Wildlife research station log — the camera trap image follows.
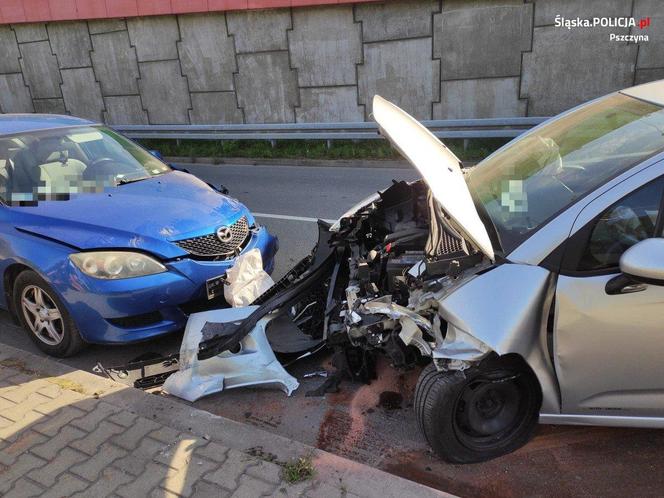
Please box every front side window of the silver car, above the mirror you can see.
[578,178,664,271]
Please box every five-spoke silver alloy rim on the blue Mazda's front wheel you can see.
[21,285,65,346]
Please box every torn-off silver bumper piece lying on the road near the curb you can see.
[164,306,299,401]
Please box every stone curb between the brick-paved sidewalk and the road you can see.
[0,345,454,498]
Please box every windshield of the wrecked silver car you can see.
[467,94,664,254]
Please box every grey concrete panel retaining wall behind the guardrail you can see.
[0,0,664,124]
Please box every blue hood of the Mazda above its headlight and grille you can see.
[8,171,253,258]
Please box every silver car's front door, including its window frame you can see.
[553,172,664,416]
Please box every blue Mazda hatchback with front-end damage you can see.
[0,114,277,357]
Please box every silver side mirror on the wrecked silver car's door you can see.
[620,238,664,285]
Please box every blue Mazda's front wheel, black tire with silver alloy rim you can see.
[12,270,85,358]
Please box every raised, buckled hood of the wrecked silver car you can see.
[373,95,495,261]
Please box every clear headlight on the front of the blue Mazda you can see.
[69,251,166,280]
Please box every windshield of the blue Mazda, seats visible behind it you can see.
[0,126,171,204]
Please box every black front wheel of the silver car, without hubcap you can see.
[415,357,542,463]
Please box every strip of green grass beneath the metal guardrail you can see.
[138,139,506,160]
